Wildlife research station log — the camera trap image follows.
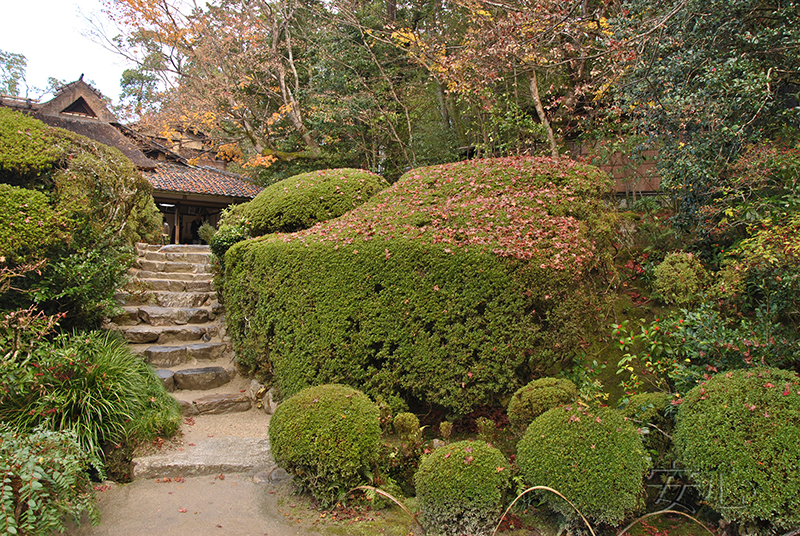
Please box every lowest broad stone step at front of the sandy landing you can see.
[131,437,276,479]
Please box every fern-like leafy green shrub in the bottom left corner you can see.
[0,423,100,536]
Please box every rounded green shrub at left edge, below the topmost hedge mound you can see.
[0,183,64,264]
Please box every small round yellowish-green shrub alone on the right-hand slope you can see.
[653,252,708,305]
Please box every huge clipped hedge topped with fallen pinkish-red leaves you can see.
[225,158,614,413]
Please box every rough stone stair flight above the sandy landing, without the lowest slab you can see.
[106,244,252,416]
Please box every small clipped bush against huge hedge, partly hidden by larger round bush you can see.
[508,378,578,434]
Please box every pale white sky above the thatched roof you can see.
[0,0,131,104]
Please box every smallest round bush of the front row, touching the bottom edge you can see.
[414,441,509,536]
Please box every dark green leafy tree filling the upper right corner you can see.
[615,0,800,234]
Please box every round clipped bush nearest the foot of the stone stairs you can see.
[269,384,381,506]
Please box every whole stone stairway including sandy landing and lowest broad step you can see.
[106,244,288,480]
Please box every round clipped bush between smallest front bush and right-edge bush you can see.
[517,406,650,525]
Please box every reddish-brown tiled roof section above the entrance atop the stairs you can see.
[145,162,262,199]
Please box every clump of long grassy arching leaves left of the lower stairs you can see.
[0,332,180,466]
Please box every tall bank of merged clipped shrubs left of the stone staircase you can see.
[0,108,161,327]
